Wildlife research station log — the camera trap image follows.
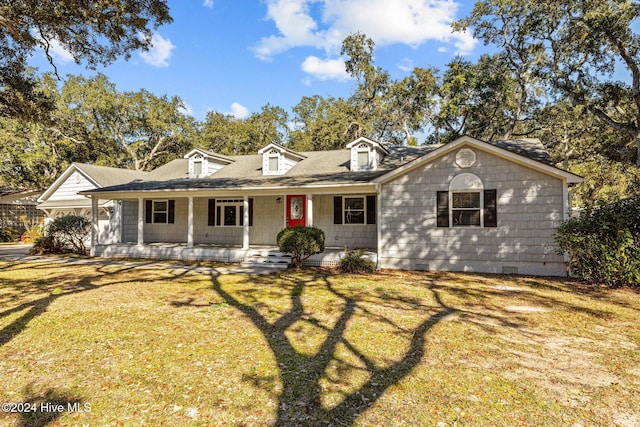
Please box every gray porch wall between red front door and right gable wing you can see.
[313,194,377,249]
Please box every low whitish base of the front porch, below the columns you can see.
[92,243,378,268]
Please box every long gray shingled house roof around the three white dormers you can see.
[76,136,582,195]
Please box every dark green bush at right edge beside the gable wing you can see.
[555,194,640,286]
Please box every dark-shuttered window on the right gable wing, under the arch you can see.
[436,190,498,227]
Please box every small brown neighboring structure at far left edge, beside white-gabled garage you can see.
[0,188,44,231]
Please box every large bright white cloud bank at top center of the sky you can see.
[255,0,477,59]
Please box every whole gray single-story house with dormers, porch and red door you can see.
[41,137,582,275]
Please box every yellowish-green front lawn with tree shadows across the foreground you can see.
[0,262,640,426]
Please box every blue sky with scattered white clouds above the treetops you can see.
[25,0,485,120]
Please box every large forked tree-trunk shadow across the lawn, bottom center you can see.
[211,275,454,426]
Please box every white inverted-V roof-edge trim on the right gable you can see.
[371,136,583,184]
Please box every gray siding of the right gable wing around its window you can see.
[379,150,565,275]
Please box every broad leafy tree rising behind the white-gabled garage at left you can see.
[61,74,196,170]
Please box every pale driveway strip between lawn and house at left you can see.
[0,243,283,276]
